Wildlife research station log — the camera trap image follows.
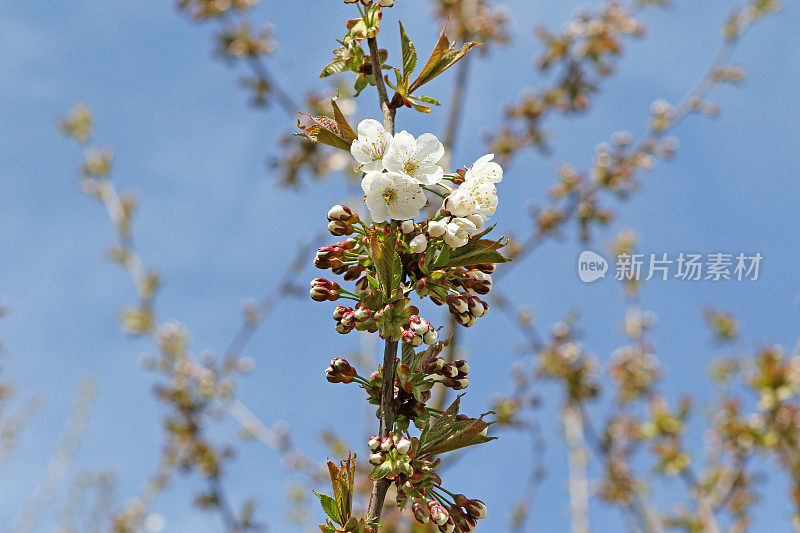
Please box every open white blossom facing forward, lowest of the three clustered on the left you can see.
[361,172,427,222]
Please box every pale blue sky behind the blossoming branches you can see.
[0,0,800,532]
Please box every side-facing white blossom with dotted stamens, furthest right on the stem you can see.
[444,154,503,218]
